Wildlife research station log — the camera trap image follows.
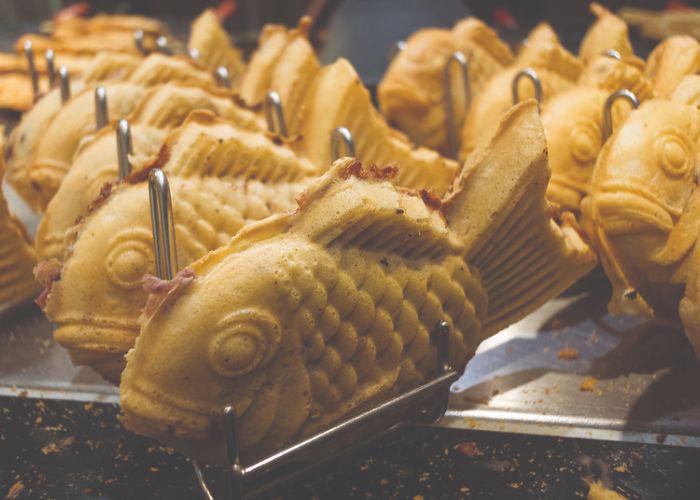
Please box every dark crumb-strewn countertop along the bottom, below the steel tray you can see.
[0,397,700,500]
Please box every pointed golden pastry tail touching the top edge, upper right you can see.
[578,2,634,64]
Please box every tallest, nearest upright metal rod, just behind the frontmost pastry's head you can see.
[148,168,178,280]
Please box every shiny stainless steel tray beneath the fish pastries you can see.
[0,287,700,447]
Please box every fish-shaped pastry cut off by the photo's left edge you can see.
[0,126,39,311]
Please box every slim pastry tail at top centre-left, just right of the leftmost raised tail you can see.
[237,17,311,107]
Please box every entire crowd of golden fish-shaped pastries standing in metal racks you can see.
[5,0,700,468]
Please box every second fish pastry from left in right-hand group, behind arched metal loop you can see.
[459,34,583,159]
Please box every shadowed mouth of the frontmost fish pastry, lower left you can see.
[120,382,213,440]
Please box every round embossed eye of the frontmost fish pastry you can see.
[208,309,282,377]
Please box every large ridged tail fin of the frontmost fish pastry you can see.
[443,99,596,335]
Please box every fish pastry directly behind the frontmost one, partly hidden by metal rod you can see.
[42,177,300,382]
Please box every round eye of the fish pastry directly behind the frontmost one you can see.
[105,228,155,289]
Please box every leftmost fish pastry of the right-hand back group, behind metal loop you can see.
[377,17,513,154]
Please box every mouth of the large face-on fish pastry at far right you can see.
[594,185,673,235]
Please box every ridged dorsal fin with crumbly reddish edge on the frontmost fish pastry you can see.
[289,158,461,259]
